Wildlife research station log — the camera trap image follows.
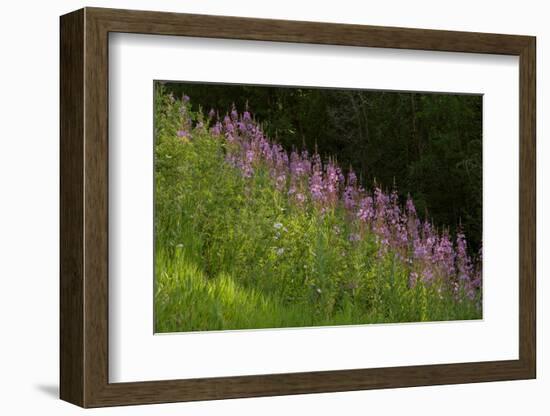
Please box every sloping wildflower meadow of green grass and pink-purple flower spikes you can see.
[154,85,482,332]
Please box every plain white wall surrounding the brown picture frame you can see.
[0,0,550,415]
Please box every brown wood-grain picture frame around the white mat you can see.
[60,8,536,407]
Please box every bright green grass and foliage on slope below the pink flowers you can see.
[155,92,480,332]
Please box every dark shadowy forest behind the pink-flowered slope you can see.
[158,83,482,251]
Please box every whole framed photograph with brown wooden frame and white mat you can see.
[60,8,536,407]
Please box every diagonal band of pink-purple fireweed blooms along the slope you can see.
[181,96,482,299]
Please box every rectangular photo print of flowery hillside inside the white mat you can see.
[154,80,483,333]
